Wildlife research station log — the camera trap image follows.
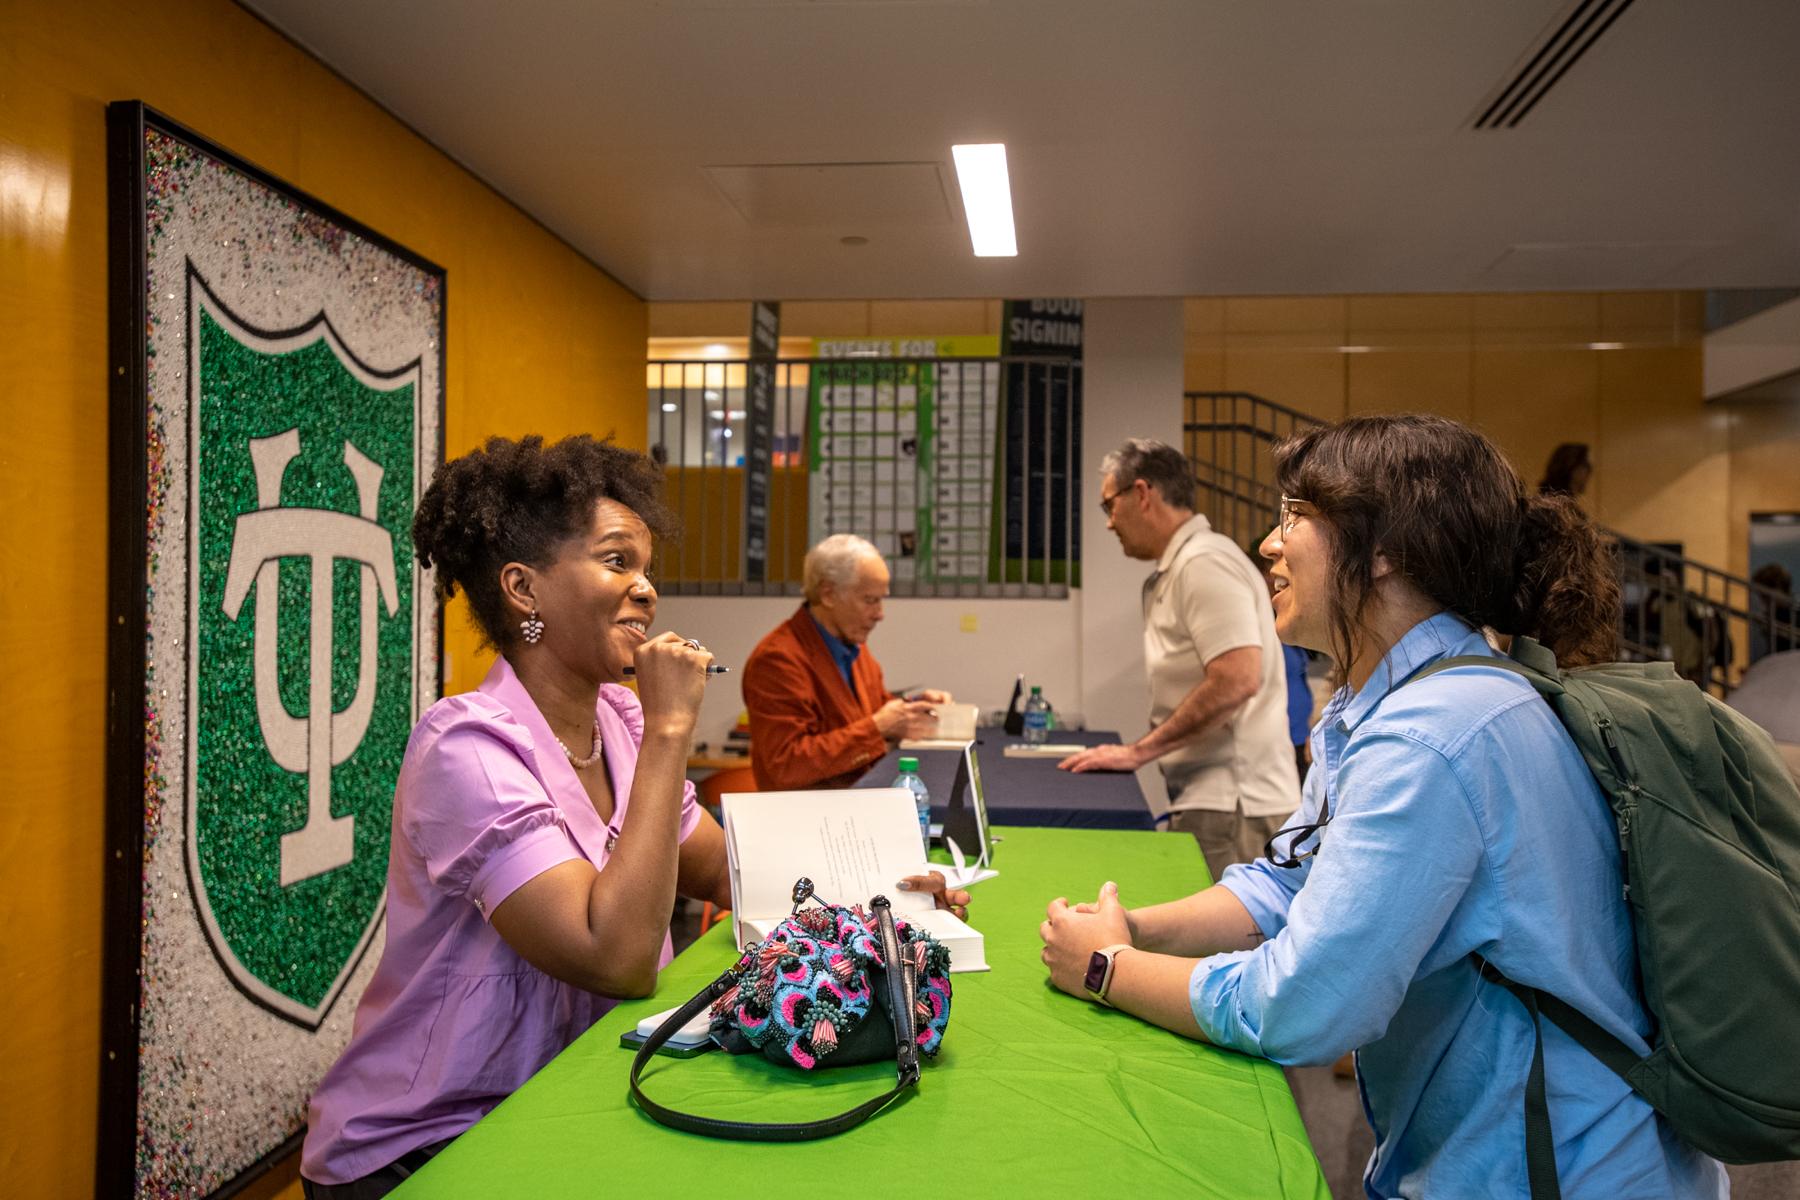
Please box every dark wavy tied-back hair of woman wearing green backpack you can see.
[1274,414,1620,667]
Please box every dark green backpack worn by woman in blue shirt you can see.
[1413,637,1800,1200]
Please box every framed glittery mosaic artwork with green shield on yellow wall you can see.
[97,103,445,1196]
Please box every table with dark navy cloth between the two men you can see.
[855,729,1154,829]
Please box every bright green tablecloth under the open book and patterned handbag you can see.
[398,828,1330,1200]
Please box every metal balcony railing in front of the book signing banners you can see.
[646,356,1082,597]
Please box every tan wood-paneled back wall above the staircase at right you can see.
[1184,291,1800,574]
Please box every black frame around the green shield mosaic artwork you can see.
[94,101,448,1200]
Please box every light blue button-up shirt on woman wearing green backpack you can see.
[1188,613,1728,1200]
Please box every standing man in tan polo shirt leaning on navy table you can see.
[1058,437,1300,882]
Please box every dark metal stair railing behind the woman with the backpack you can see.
[1183,392,1800,696]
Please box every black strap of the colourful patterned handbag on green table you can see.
[632,896,918,1142]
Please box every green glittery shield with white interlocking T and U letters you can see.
[187,266,417,1029]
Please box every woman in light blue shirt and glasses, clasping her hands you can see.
[1042,416,1728,1200]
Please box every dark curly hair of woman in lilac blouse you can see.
[412,434,675,649]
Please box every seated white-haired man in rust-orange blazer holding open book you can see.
[743,533,950,792]
